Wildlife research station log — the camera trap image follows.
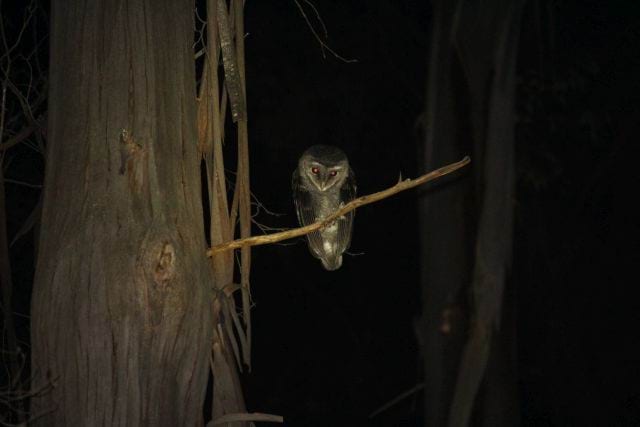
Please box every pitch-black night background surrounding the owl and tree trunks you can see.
[3,0,640,426]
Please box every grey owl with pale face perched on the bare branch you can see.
[291,145,356,271]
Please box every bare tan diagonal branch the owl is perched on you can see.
[207,156,471,256]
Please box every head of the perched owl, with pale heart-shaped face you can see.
[298,145,349,192]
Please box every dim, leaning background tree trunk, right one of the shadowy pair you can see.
[449,0,522,427]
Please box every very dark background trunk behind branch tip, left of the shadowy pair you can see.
[419,1,470,426]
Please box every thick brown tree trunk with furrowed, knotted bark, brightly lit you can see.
[32,0,212,426]
